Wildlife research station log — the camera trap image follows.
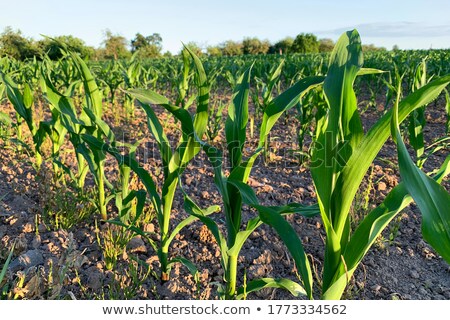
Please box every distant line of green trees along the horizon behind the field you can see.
[0,27,385,60]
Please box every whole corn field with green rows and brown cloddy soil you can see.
[0,30,450,299]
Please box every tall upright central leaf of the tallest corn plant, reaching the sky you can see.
[311,30,364,290]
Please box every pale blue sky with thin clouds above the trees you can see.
[0,0,450,53]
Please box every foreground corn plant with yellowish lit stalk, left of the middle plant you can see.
[89,46,218,281]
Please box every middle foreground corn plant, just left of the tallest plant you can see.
[173,62,323,299]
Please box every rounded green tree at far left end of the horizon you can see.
[0,27,40,60]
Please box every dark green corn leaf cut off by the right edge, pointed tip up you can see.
[392,92,450,263]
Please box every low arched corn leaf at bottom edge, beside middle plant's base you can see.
[236,278,307,300]
